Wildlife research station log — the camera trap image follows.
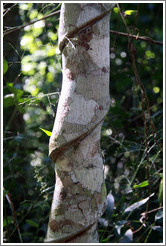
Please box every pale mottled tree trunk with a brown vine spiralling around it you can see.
[45,3,113,243]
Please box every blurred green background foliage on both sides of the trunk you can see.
[3,2,163,243]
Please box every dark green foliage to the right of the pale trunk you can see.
[100,4,163,243]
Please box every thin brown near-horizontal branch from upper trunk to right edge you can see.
[110,30,163,45]
